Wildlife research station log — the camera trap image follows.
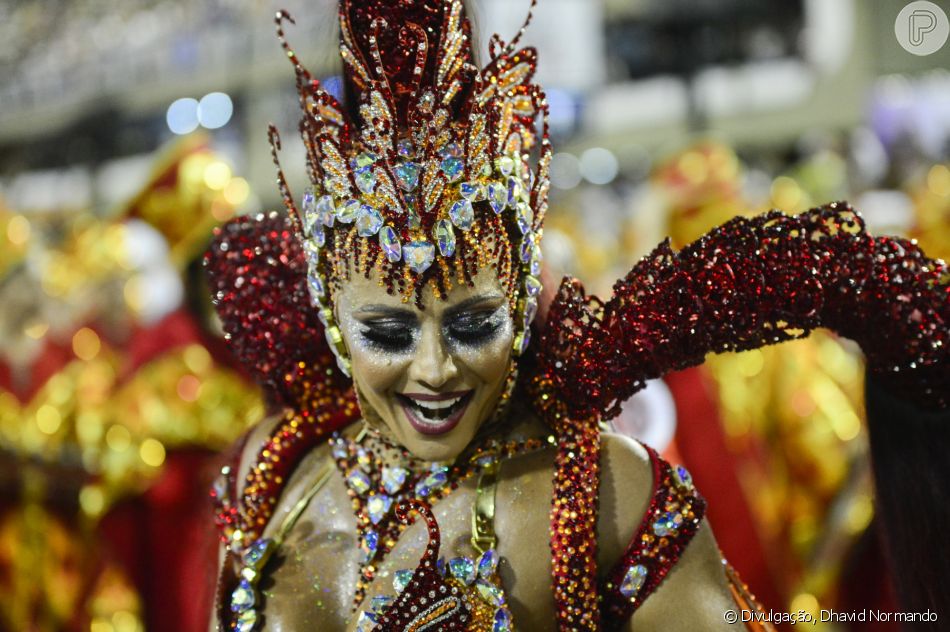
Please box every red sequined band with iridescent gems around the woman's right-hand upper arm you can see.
[602,446,706,629]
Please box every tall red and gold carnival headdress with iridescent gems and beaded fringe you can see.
[270,0,551,373]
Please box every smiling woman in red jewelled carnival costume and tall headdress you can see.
[207,0,950,631]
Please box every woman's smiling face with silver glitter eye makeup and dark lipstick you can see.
[335,267,514,461]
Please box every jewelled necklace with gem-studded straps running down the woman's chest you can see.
[229,426,553,632]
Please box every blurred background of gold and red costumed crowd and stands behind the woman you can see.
[0,0,950,632]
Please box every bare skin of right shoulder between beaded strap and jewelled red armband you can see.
[597,433,653,576]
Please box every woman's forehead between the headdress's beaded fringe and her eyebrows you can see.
[336,266,505,313]
